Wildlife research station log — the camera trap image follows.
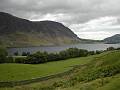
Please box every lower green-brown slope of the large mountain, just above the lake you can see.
[0,32,78,47]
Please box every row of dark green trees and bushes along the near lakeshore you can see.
[0,47,120,64]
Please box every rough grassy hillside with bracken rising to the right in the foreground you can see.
[1,51,120,90]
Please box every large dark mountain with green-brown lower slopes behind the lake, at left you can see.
[0,12,80,47]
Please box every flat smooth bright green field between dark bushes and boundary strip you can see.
[0,52,97,81]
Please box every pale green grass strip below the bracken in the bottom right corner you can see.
[59,74,120,90]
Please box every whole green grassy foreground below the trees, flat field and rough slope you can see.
[0,51,120,90]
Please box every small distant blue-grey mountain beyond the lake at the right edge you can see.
[104,34,120,44]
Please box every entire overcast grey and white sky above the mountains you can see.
[0,0,120,40]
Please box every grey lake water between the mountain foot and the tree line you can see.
[7,44,120,55]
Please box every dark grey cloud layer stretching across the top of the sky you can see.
[0,0,120,22]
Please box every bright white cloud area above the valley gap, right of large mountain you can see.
[70,16,120,40]
